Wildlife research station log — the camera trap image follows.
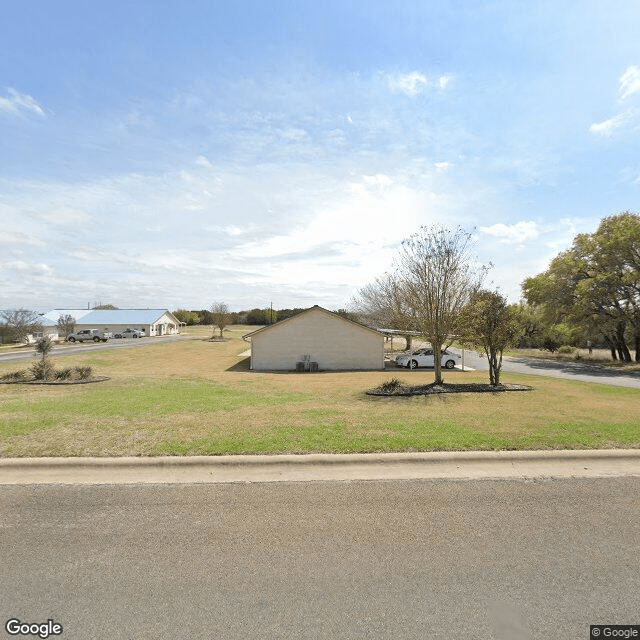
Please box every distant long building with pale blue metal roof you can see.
[35,309,180,338]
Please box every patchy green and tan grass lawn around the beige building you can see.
[0,327,640,457]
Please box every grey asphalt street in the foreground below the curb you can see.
[0,478,640,640]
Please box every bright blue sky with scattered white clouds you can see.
[0,0,640,310]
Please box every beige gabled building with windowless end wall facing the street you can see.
[243,305,384,371]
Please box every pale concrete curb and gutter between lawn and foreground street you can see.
[0,449,640,485]
